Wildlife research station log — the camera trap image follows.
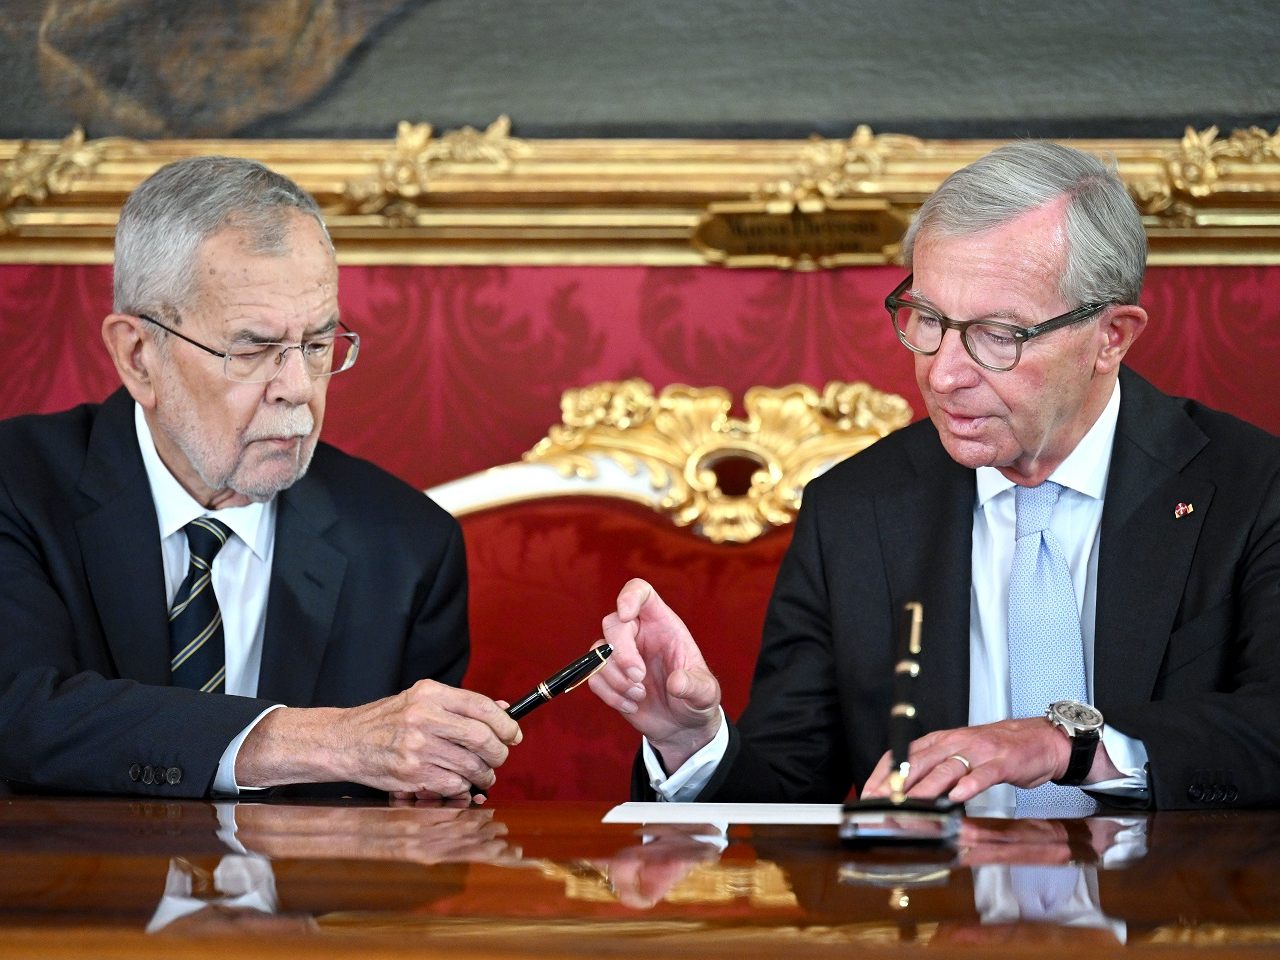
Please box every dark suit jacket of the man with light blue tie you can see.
[700,370,1280,808]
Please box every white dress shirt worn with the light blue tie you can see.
[641,381,1147,815]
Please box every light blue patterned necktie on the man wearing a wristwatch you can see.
[1009,480,1097,817]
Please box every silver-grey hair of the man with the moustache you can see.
[113,156,333,323]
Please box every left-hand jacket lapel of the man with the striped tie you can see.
[76,389,170,685]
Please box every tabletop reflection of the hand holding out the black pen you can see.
[236,804,520,864]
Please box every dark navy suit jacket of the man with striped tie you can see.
[0,390,467,796]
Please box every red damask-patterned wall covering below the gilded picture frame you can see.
[0,265,1280,486]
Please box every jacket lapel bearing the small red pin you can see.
[1093,370,1215,713]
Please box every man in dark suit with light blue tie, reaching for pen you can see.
[591,142,1280,812]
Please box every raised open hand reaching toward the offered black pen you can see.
[589,580,721,772]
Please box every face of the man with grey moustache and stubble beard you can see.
[148,214,338,507]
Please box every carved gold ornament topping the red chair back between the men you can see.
[525,379,911,543]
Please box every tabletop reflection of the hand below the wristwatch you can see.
[956,817,1124,867]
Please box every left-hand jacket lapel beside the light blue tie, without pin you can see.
[879,429,977,731]
